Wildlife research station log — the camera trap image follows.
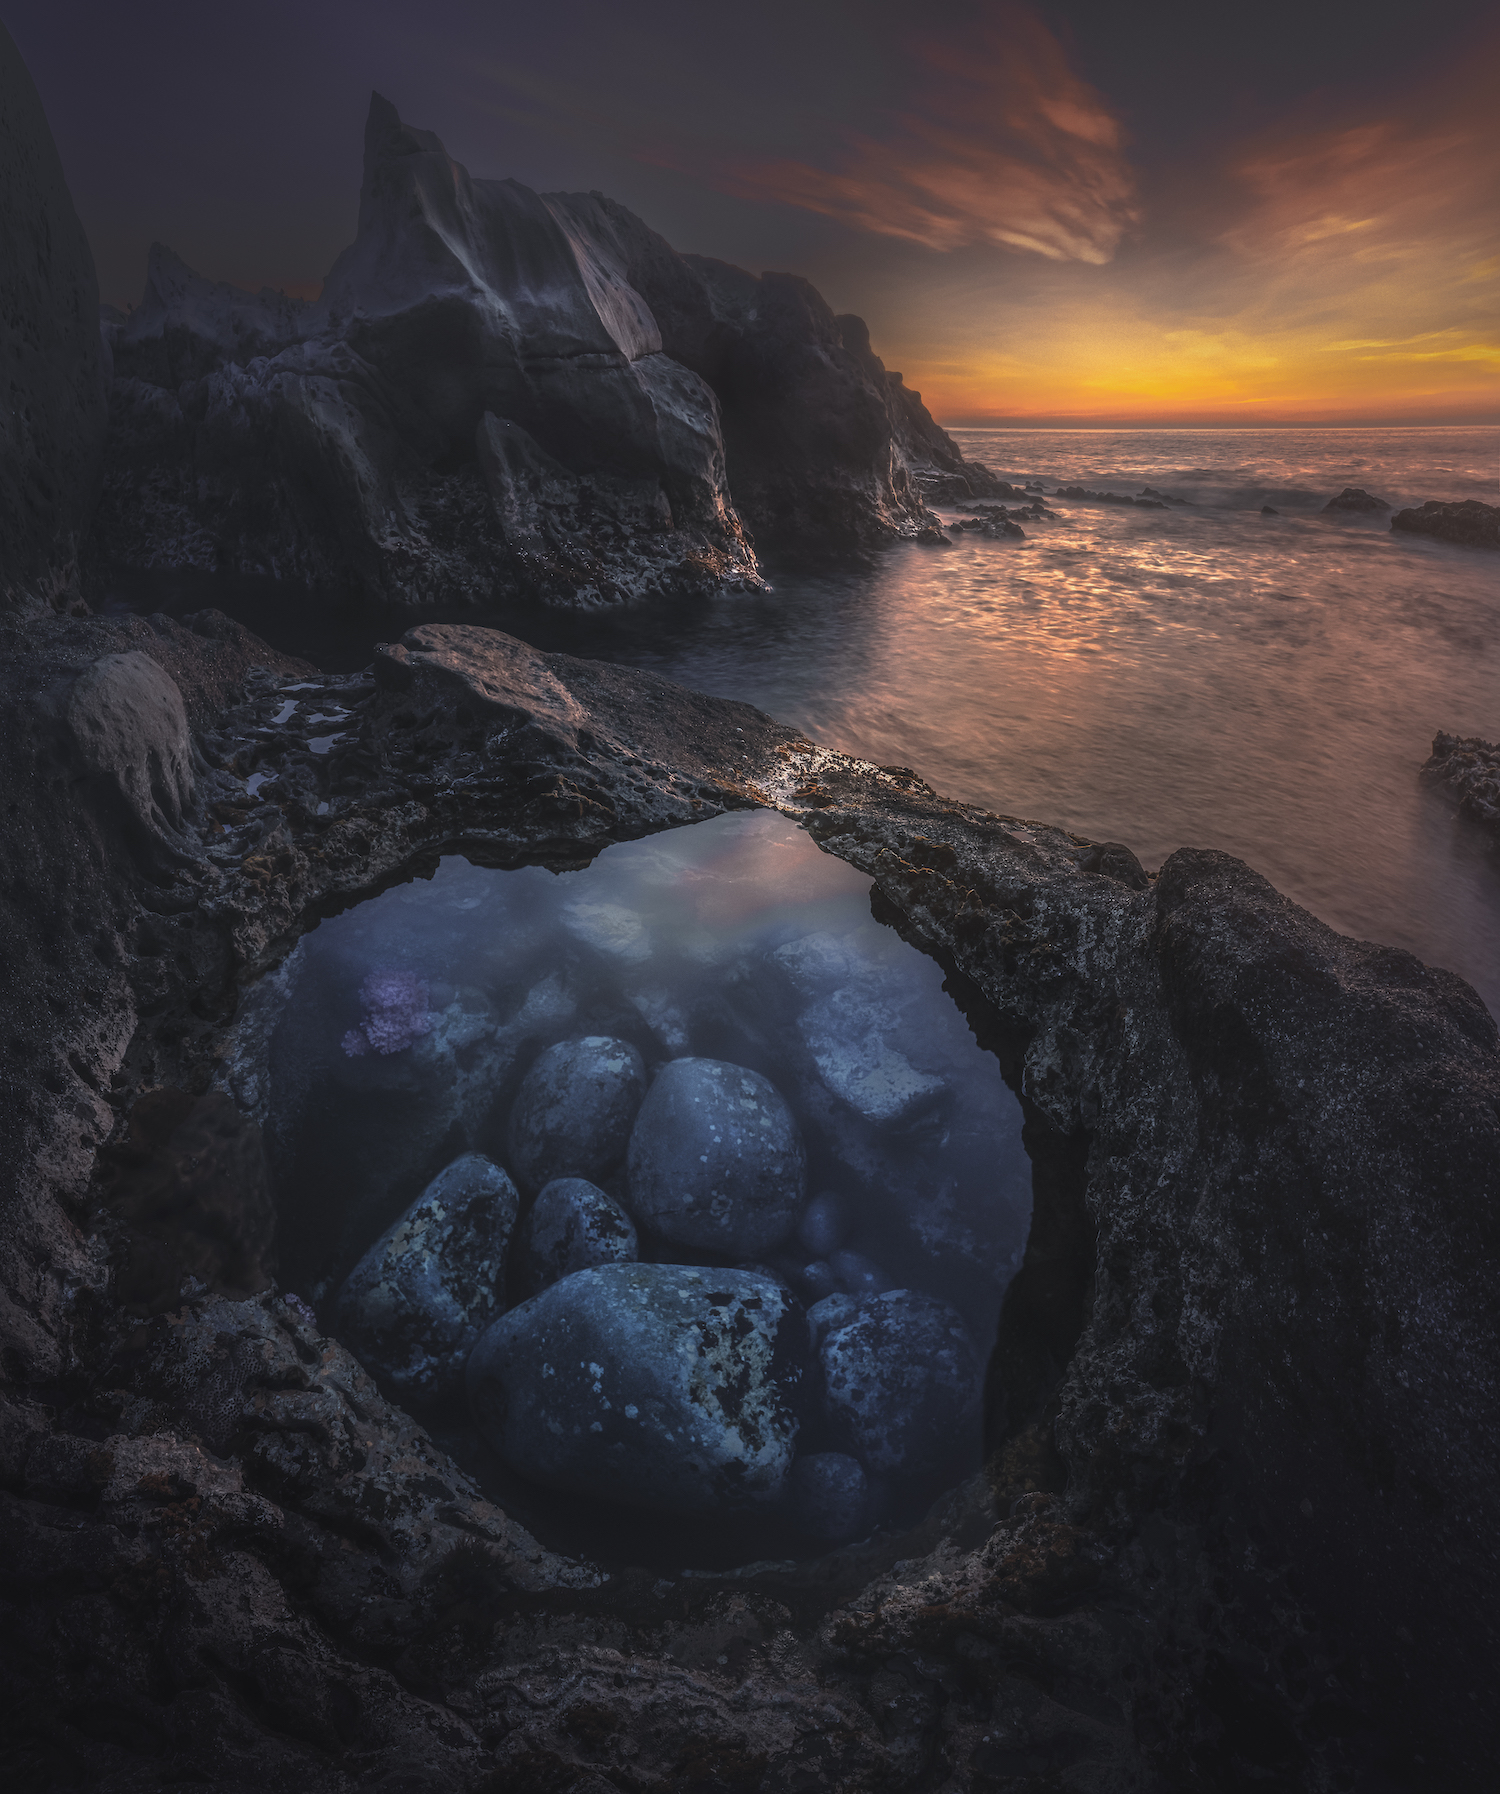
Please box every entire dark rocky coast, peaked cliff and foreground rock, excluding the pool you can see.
[0,21,1500,1794]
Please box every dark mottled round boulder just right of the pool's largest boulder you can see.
[818,1290,980,1475]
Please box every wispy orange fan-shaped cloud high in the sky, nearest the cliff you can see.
[653,5,1138,264]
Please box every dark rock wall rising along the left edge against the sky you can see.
[0,25,108,612]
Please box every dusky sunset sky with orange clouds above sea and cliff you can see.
[11,0,1500,427]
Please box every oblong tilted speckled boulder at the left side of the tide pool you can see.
[337,1154,520,1401]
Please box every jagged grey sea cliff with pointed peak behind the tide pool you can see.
[99,95,985,608]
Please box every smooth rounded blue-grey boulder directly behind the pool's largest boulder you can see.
[628,1058,807,1258]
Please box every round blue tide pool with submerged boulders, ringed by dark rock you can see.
[267,813,1032,1564]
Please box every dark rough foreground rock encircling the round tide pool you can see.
[0,619,1500,1794]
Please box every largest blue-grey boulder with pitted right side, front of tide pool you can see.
[468,1265,806,1514]
